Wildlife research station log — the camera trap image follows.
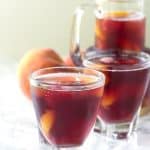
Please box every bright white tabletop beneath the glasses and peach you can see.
[0,66,150,150]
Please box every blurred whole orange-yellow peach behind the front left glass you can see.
[17,48,64,99]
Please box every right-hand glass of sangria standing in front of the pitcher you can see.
[83,51,150,139]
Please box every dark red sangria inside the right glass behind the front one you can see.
[87,55,150,123]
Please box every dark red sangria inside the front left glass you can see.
[32,74,103,147]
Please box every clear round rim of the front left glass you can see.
[29,66,105,91]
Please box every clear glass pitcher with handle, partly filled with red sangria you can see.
[70,0,146,65]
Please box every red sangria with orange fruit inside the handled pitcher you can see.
[95,12,145,51]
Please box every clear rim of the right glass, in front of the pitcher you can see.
[83,51,150,72]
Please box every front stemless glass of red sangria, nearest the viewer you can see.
[30,67,105,149]
